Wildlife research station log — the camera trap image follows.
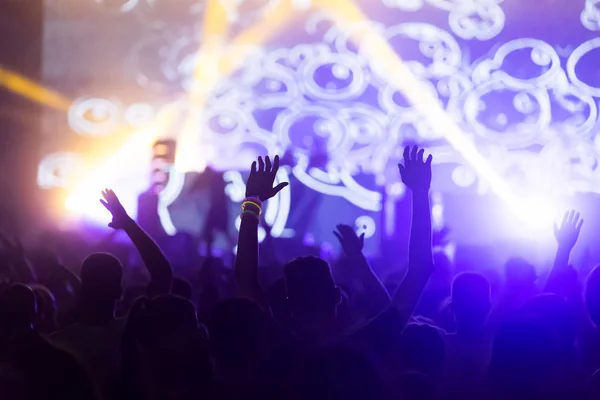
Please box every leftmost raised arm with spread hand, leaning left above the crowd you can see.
[100,190,173,295]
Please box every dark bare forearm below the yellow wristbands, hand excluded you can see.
[234,217,267,307]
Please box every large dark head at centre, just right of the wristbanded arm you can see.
[284,256,341,318]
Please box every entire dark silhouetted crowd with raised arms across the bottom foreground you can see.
[0,147,600,400]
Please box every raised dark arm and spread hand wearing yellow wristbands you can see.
[234,156,288,309]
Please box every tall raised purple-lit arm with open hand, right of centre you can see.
[392,146,433,332]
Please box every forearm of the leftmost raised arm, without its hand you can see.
[125,219,173,294]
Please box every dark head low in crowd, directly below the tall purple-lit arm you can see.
[400,323,446,378]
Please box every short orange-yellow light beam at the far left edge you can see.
[0,67,71,110]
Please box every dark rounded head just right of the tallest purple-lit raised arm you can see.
[451,272,492,335]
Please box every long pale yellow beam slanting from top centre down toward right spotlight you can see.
[317,0,520,212]
